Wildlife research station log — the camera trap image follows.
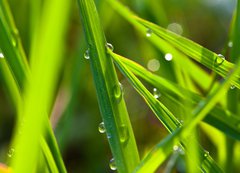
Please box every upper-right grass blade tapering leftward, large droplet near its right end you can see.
[135,17,240,88]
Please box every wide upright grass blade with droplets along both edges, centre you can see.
[78,0,139,173]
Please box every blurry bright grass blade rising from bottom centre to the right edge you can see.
[129,51,240,172]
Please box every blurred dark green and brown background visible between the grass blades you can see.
[0,0,240,173]
